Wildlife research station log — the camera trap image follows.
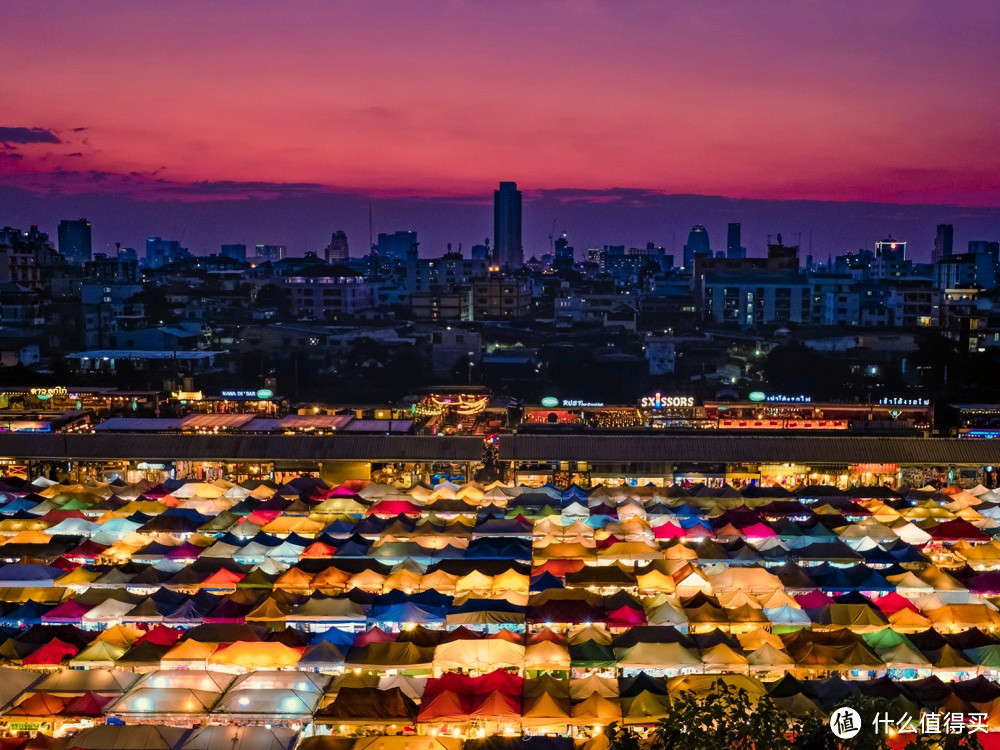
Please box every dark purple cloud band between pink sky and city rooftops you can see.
[0,183,1000,264]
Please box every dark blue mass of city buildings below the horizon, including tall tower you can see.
[0,182,1000,418]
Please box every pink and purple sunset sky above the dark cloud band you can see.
[0,0,1000,206]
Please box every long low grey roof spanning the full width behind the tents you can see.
[0,433,1000,465]
